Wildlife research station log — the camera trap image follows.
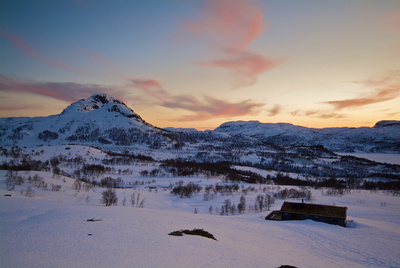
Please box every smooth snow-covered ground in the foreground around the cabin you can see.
[0,166,400,267]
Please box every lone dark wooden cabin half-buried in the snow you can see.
[265,202,347,227]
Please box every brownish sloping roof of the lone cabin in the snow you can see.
[281,202,347,219]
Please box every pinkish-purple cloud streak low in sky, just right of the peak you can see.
[130,76,264,121]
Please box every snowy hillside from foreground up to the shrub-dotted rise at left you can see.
[0,145,400,267]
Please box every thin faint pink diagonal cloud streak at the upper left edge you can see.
[0,29,86,73]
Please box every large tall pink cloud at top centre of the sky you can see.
[181,0,283,88]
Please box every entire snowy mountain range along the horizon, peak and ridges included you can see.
[0,94,400,153]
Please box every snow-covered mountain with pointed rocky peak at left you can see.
[0,94,165,147]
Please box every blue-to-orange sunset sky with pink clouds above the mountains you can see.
[0,0,400,130]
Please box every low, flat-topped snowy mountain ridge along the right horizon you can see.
[214,121,400,152]
